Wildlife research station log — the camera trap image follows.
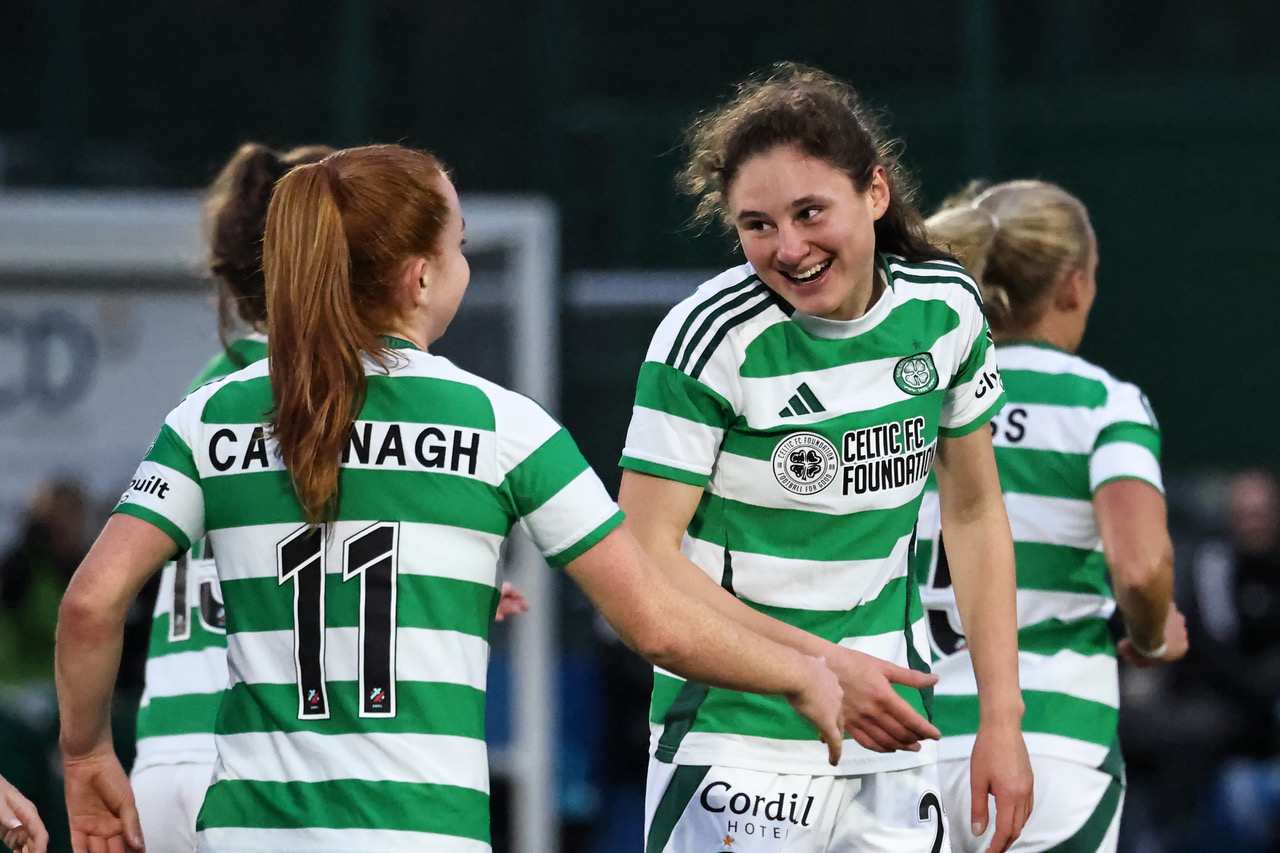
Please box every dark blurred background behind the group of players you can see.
[0,0,1280,853]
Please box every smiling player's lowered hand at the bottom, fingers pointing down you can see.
[969,722,1034,853]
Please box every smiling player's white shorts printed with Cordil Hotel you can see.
[645,757,950,853]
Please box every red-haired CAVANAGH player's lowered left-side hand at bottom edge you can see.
[63,744,143,853]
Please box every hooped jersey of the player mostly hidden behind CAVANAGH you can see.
[133,334,266,771]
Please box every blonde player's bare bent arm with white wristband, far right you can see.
[1093,479,1187,667]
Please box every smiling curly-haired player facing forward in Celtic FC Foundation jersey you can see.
[620,65,1032,853]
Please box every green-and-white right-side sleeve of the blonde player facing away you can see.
[1089,383,1165,492]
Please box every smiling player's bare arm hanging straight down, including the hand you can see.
[937,428,1033,853]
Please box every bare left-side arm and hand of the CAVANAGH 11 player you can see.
[55,515,174,853]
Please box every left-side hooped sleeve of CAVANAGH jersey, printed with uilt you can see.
[113,397,205,551]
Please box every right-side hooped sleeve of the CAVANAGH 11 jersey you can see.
[494,393,622,566]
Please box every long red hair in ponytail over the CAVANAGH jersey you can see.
[262,145,449,524]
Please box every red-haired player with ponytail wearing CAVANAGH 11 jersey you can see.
[58,146,842,853]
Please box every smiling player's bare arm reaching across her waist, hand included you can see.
[618,470,941,752]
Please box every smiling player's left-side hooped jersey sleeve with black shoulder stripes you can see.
[620,298,737,488]
